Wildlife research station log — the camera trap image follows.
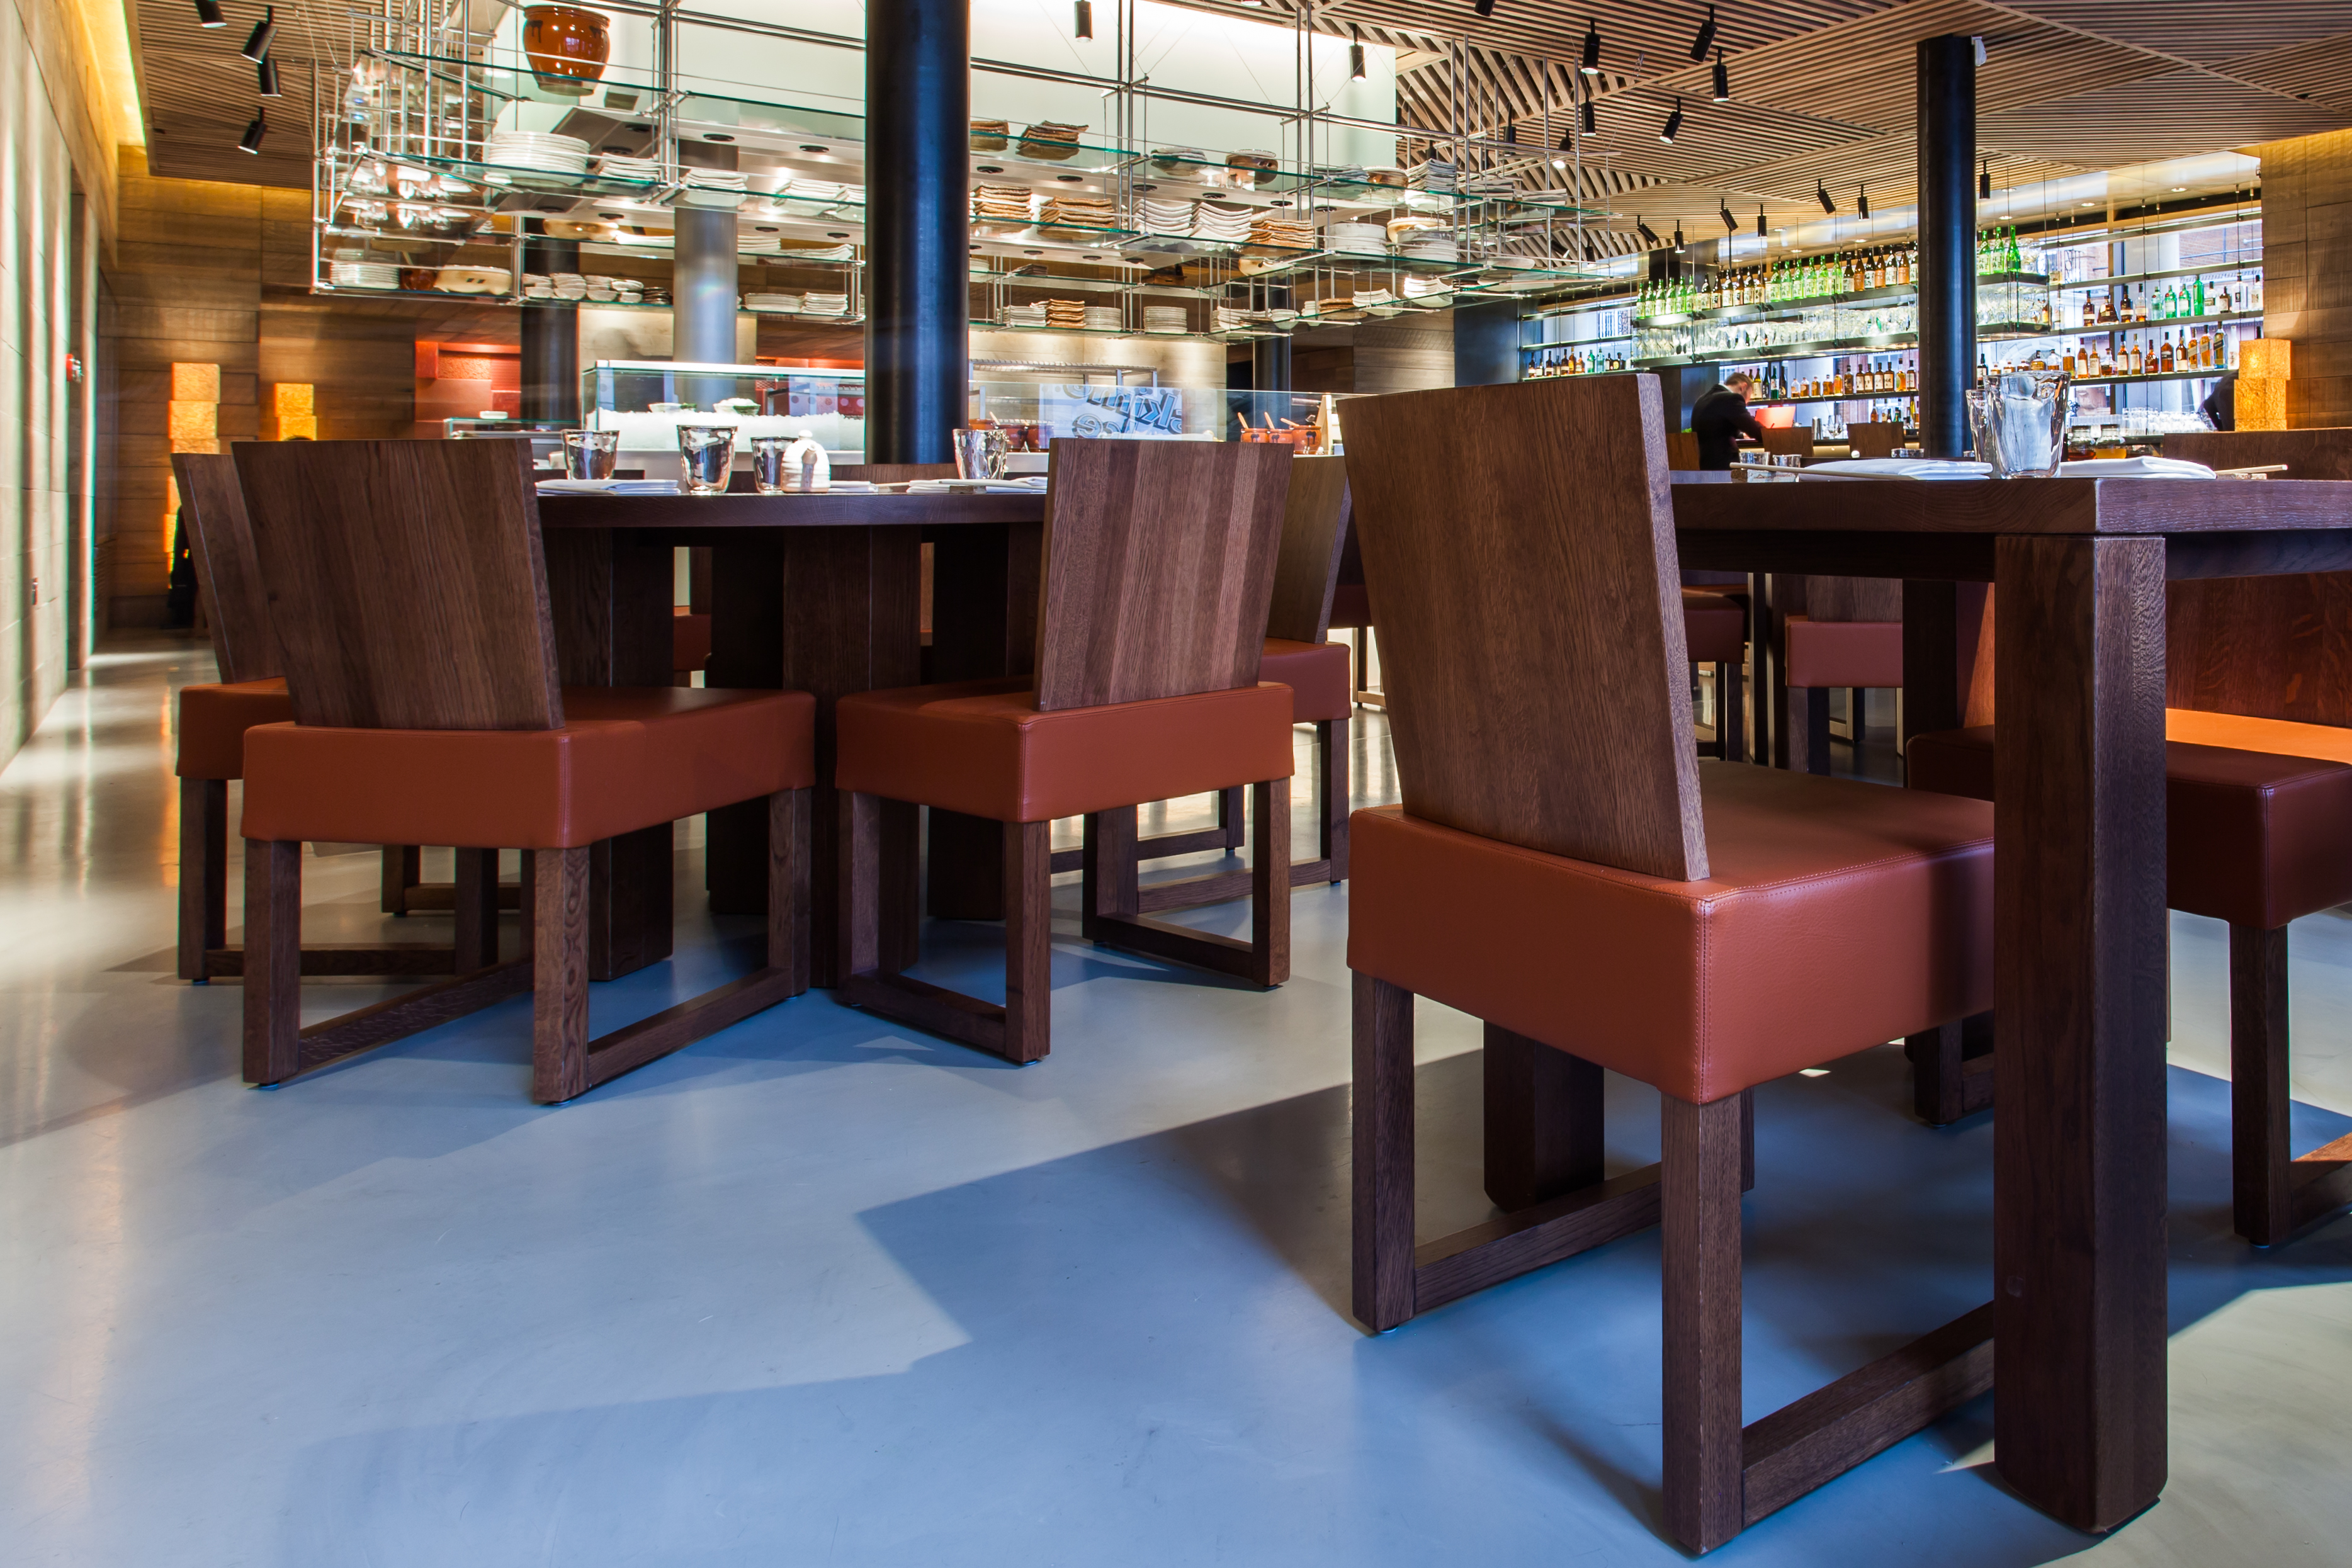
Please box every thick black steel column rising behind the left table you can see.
[866,0,971,463]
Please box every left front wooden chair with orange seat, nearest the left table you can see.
[235,442,816,1103]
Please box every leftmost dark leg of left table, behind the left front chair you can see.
[543,529,675,980]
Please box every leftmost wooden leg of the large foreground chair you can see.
[1352,973,1413,1333]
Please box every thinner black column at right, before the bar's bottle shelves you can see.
[1919,33,1976,458]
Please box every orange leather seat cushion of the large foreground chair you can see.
[1348,762,1992,1105]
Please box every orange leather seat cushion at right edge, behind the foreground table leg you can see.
[1908,708,2352,931]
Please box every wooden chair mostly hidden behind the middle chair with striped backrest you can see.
[1054,458,1355,915]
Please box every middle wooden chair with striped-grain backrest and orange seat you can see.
[835,439,1294,1063]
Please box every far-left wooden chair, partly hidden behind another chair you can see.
[172,451,456,985]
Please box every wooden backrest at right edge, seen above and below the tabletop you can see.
[2164,430,2352,726]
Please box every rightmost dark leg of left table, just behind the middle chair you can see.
[924,522,1044,919]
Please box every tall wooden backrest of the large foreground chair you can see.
[1348,376,1707,881]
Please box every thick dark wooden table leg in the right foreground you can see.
[1994,536,2166,1530]
